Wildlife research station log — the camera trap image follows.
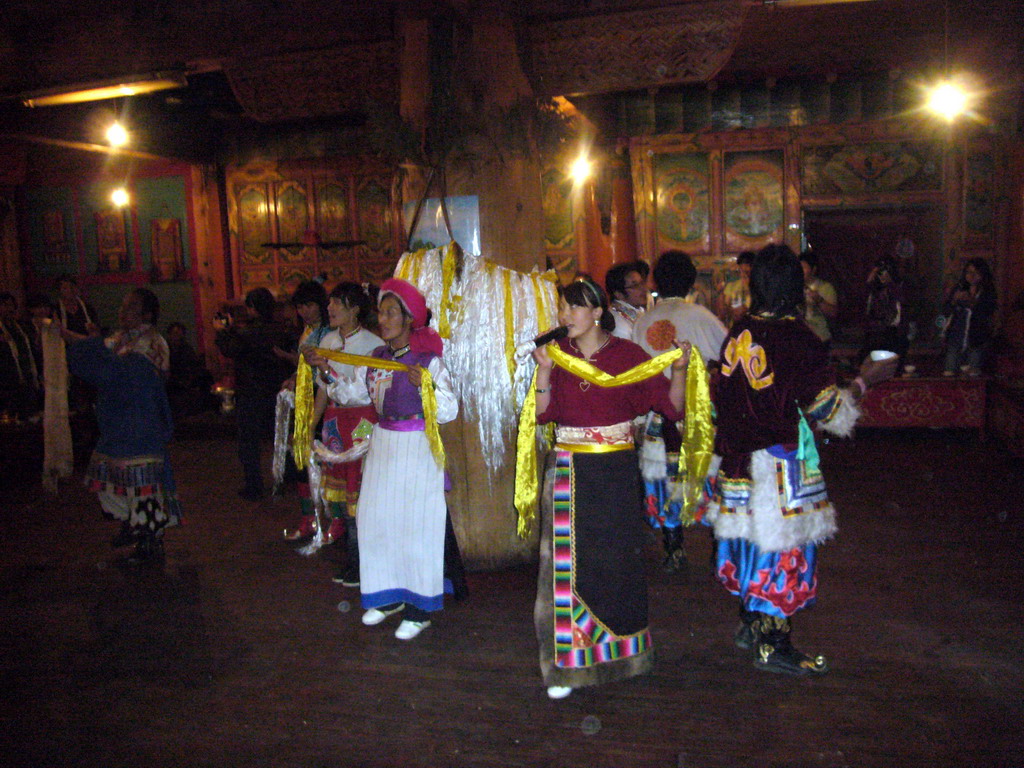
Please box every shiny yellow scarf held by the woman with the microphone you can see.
[514,344,714,538]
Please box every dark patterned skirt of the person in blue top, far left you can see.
[85,453,181,534]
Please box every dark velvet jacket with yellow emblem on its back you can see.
[715,315,835,476]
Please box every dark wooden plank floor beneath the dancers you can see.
[0,421,1024,768]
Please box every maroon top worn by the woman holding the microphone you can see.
[537,336,683,427]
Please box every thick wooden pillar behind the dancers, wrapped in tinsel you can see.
[400,10,544,569]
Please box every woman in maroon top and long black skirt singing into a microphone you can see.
[520,279,689,698]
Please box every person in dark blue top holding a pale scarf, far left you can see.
[66,288,181,562]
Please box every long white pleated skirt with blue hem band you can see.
[356,425,445,611]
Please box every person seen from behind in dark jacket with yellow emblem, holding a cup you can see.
[706,246,896,675]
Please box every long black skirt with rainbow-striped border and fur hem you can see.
[535,449,653,687]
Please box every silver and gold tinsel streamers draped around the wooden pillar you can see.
[395,248,558,481]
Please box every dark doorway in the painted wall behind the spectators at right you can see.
[804,206,943,345]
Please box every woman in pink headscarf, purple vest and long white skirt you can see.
[310,279,459,640]
